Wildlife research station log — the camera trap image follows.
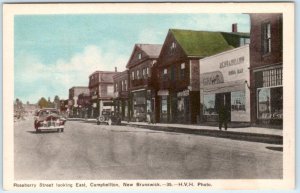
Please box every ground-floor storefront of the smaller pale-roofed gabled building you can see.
[131,89,153,122]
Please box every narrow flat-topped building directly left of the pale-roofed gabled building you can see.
[113,70,130,121]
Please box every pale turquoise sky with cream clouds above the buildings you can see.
[14,14,250,103]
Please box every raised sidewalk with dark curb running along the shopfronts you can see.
[122,121,283,144]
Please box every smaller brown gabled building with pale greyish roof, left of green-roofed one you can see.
[126,44,161,121]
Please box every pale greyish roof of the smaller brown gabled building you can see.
[126,44,162,68]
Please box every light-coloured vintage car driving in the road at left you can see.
[34,108,66,132]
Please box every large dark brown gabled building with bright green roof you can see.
[156,29,249,123]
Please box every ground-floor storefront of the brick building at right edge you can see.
[254,65,283,125]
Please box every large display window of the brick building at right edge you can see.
[257,87,283,119]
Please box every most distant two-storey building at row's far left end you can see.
[68,86,89,117]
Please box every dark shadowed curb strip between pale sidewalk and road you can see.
[128,124,283,145]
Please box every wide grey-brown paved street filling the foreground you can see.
[14,119,283,180]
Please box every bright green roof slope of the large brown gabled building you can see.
[169,29,249,57]
